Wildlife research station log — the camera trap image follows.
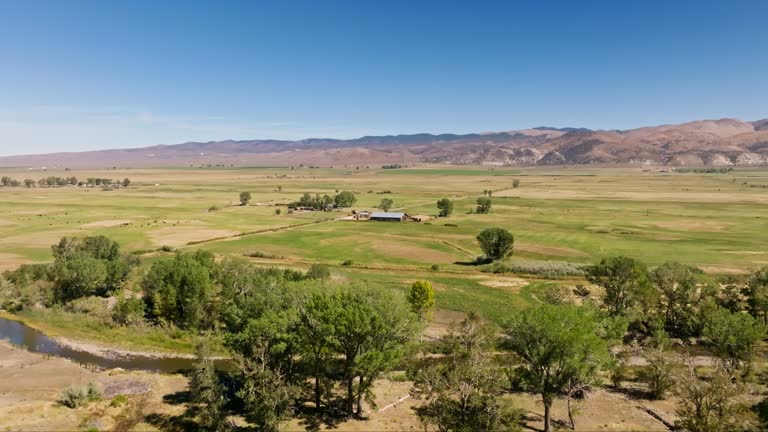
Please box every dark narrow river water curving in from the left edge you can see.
[0,317,228,373]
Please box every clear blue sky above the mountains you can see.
[0,0,768,155]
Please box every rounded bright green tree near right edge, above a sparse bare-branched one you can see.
[702,308,765,373]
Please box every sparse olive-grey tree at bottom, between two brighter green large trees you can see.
[411,315,519,432]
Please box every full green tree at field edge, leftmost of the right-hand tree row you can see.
[584,256,652,316]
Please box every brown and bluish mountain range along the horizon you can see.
[0,119,768,168]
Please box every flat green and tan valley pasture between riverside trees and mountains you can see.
[0,166,768,322]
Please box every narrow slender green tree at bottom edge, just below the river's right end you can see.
[189,342,231,432]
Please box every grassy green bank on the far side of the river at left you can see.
[0,310,228,360]
